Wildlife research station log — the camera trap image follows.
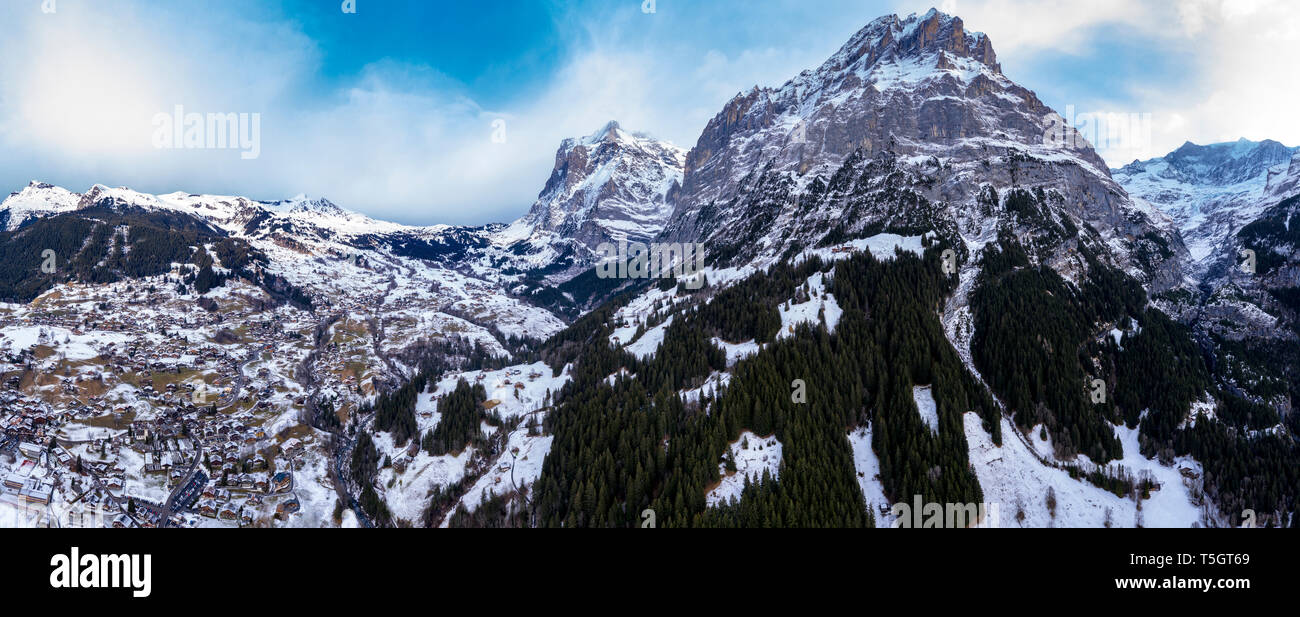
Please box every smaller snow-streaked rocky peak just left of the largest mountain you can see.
[494,121,686,281]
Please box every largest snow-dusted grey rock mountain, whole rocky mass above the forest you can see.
[667,10,1183,288]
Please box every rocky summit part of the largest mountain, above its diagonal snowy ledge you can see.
[670,10,1076,214]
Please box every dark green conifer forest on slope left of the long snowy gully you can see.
[534,248,1000,526]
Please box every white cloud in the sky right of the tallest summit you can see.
[904,0,1300,159]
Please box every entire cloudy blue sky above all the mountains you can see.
[0,0,1300,223]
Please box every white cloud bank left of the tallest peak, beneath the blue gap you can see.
[0,0,847,223]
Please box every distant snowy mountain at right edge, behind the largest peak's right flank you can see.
[1113,139,1300,340]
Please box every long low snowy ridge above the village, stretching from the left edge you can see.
[0,182,563,349]
